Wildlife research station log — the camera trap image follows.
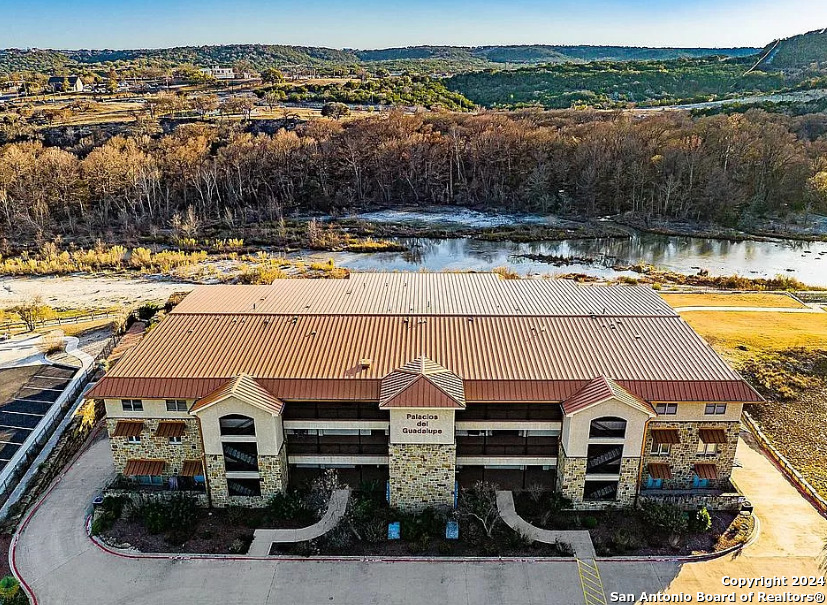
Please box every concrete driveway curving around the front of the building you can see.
[12,438,825,605]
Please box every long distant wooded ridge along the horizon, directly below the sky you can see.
[0,44,759,73]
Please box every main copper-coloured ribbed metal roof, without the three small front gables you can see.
[91,274,761,402]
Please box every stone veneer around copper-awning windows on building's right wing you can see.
[643,422,741,489]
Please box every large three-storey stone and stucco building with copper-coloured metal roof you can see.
[91,273,760,509]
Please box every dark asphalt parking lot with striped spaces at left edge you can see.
[0,365,77,470]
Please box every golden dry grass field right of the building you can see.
[664,293,827,497]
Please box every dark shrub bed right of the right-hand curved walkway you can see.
[514,491,752,556]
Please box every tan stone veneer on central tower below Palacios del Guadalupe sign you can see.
[388,443,457,510]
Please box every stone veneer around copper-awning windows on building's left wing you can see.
[106,418,204,479]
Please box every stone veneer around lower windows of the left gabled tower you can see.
[206,445,287,508]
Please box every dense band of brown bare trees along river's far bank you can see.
[0,111,827,242]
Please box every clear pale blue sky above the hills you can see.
[0,0,827,49]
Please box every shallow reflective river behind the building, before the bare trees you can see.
[304,212,827,287]
